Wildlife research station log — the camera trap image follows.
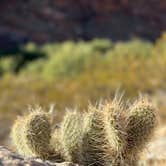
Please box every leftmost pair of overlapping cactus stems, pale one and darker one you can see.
[11,107,56,159]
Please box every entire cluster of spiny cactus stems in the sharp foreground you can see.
[11,97,156,166]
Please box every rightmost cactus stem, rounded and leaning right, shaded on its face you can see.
[125,98,156,165]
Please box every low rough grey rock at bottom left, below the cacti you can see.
[0,146,78,166]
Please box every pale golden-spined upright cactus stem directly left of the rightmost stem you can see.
[103,98,126,165]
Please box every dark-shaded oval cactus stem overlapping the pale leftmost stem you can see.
[24,109,51,159]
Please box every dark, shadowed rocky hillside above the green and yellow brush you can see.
[0,0,166,46]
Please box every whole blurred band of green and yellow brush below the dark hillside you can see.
[0,34,166,147]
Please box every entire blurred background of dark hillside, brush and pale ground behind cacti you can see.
[0,0,166,165]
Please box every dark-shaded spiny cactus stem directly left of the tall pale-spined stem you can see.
[81,107,107,166]
